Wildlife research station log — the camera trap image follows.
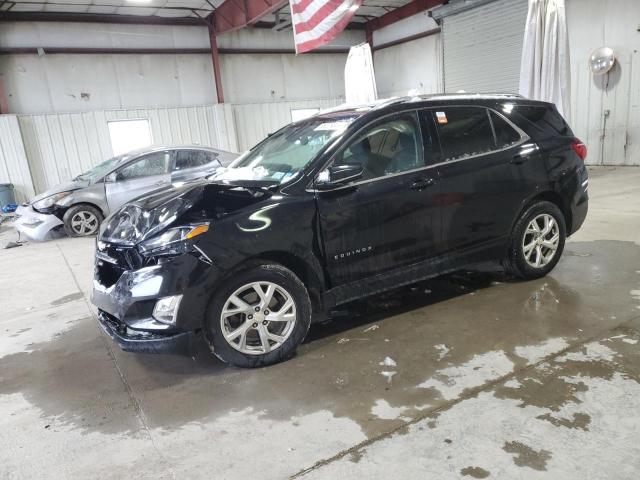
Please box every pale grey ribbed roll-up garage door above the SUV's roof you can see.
[442,0,527,93]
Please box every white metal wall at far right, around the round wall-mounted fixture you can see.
[567,0,640,165]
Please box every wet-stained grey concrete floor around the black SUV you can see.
[0,168,640,479]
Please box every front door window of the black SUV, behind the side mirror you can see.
[333,112,425,180]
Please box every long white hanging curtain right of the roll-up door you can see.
[520,0,571,122]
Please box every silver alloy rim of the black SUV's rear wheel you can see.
[522,213,560,268]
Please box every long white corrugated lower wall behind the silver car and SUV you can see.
[0,98,342,201]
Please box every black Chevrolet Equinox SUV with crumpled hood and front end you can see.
[93,95,588,367]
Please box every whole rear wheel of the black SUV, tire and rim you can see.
[508,201,567,280]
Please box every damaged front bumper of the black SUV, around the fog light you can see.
[91,247,217,353]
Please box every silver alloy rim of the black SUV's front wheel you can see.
[220,281,297,355]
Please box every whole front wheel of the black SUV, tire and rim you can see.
[207,264,312,368]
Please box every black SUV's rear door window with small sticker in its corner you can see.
[433,107,495,162]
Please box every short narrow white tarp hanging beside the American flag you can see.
[344,43,378,105]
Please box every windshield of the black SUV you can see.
[209,116,356,184]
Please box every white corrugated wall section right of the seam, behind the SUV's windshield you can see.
[234,98,344,151]
